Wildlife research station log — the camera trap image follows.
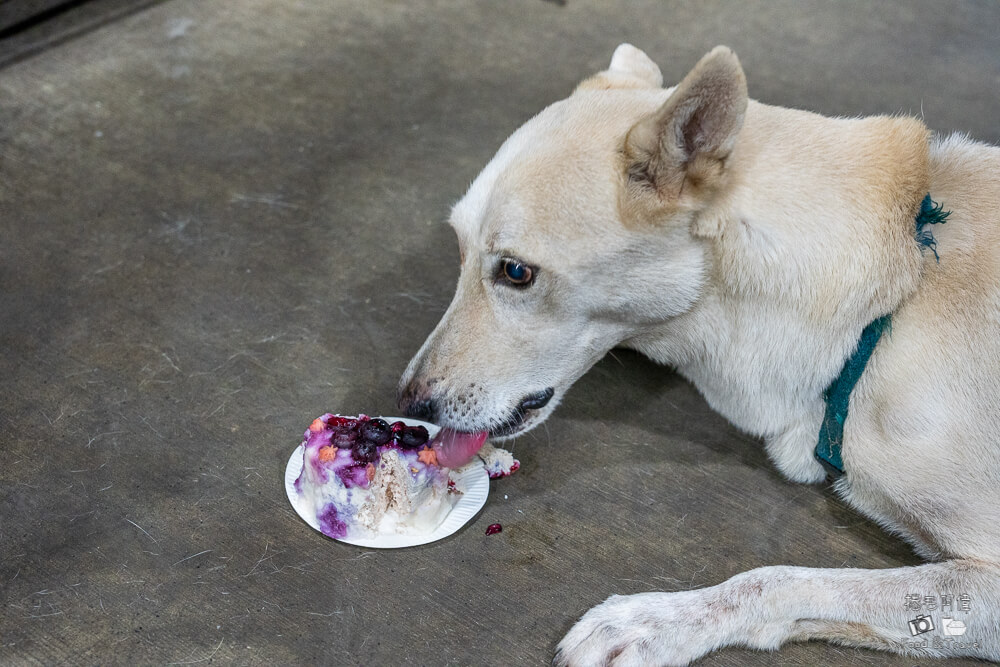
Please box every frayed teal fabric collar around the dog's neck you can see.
[816,195,951,477]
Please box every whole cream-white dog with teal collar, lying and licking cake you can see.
[400,44,1000,665]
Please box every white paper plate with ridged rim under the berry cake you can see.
[285,417,490,549]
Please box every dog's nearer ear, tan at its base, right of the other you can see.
[624,46,747,200]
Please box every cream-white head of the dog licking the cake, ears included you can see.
[399,44,747,436]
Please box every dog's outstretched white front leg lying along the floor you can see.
[553,560,1000,665]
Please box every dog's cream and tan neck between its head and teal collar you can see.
[629,103,929,437]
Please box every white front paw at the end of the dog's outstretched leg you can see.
[552,589,722,667]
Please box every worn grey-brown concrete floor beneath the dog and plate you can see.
[0,0,1000,667]
